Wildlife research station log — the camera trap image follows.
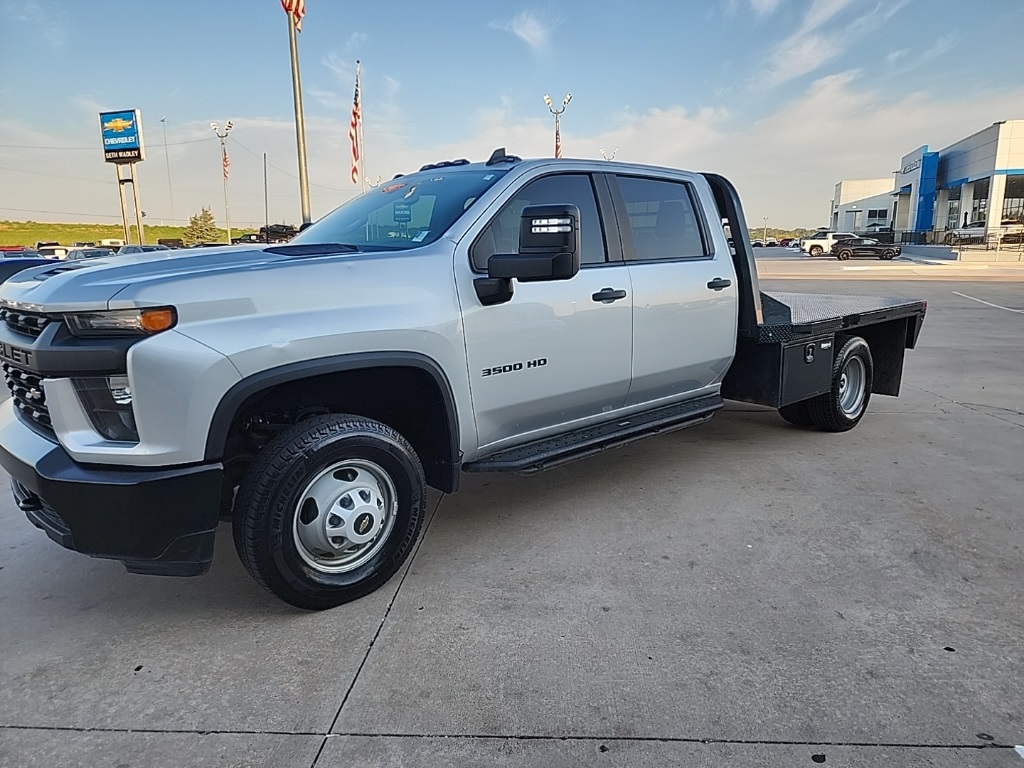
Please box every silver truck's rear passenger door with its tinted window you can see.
[610,174,738,406]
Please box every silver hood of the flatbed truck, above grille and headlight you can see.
[0,244,300,312]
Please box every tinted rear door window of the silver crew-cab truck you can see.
[616,176,709,261]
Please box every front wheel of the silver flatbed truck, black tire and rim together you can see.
[232,415,426,610]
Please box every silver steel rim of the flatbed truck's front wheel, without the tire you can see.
[292,459,398,573]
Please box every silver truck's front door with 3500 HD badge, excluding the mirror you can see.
[459,173,633,449]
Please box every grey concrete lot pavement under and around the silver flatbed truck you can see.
[0,280,1024,768]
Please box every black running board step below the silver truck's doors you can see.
[462,394,725,475]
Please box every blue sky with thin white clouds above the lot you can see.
[0,0,1024,227]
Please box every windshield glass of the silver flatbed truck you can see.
[291,168,508,251]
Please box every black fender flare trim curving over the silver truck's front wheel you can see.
[205,352,462,482]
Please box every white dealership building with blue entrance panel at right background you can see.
[830,120,1024,243]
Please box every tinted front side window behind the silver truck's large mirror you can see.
[471,173,607,272]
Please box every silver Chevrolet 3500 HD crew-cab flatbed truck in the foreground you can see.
[0,150,926,608]
